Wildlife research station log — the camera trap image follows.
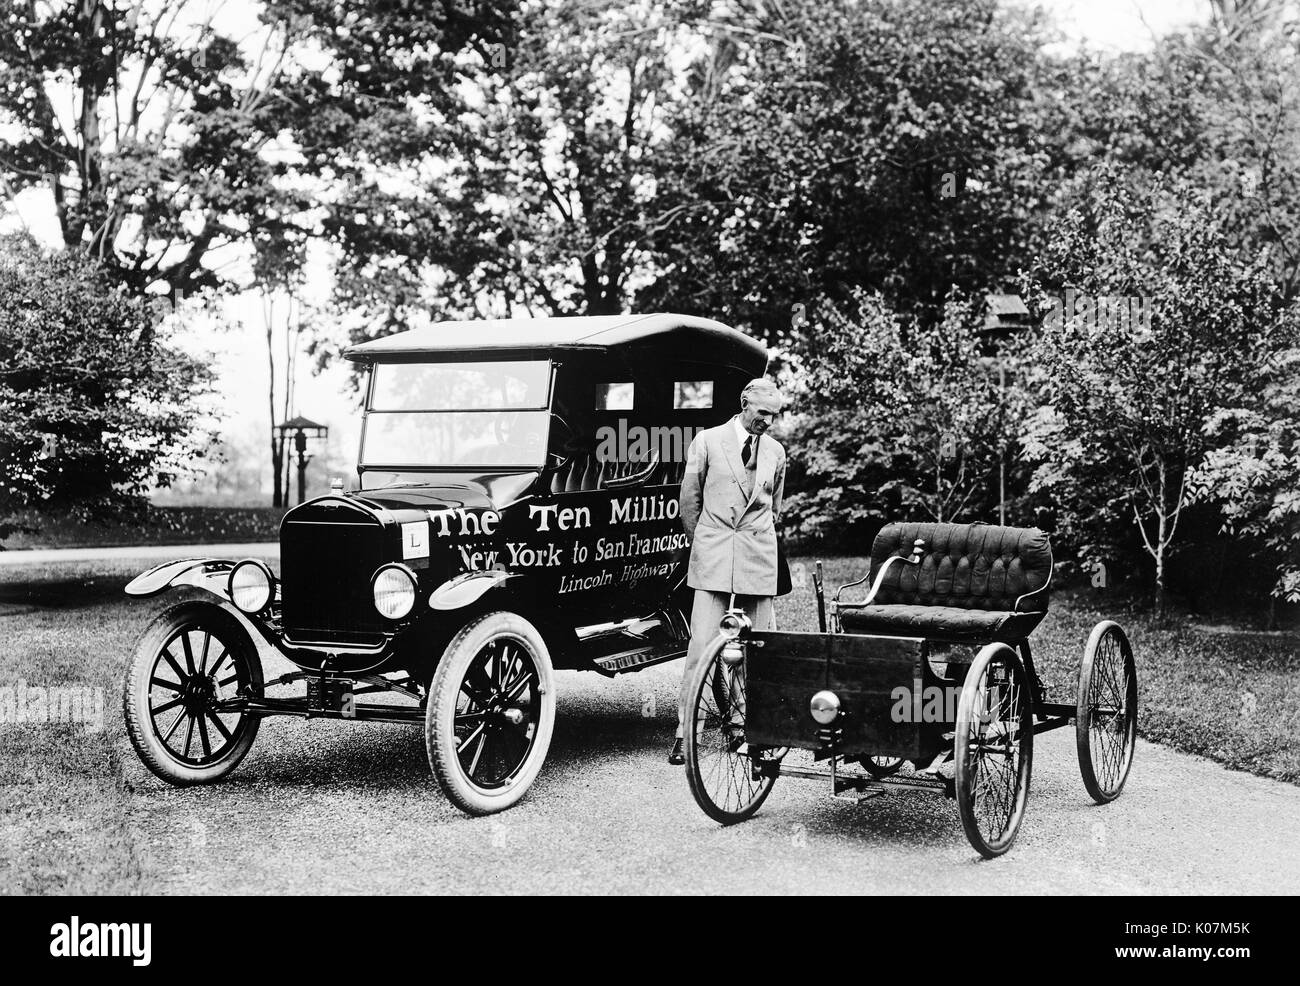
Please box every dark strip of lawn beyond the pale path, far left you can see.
[0,506,285,550]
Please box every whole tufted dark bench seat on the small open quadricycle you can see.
[840,524,1052,643]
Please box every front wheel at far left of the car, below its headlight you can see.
[122,602,263,786]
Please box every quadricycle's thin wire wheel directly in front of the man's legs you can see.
[683,636,785,825]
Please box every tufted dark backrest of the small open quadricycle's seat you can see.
[871,523,1052,613]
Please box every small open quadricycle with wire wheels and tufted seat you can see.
[685,524,1138,857]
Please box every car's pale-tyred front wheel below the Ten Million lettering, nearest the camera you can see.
[424,611,555,814]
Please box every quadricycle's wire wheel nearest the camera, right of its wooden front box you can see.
[953,644,1034,859]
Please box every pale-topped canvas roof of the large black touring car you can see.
[343,312,767,376]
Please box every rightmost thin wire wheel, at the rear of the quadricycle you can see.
[1074,619,1138,804]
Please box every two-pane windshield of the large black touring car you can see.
[361,359,551,467]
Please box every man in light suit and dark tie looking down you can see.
[668,379,785,764]
